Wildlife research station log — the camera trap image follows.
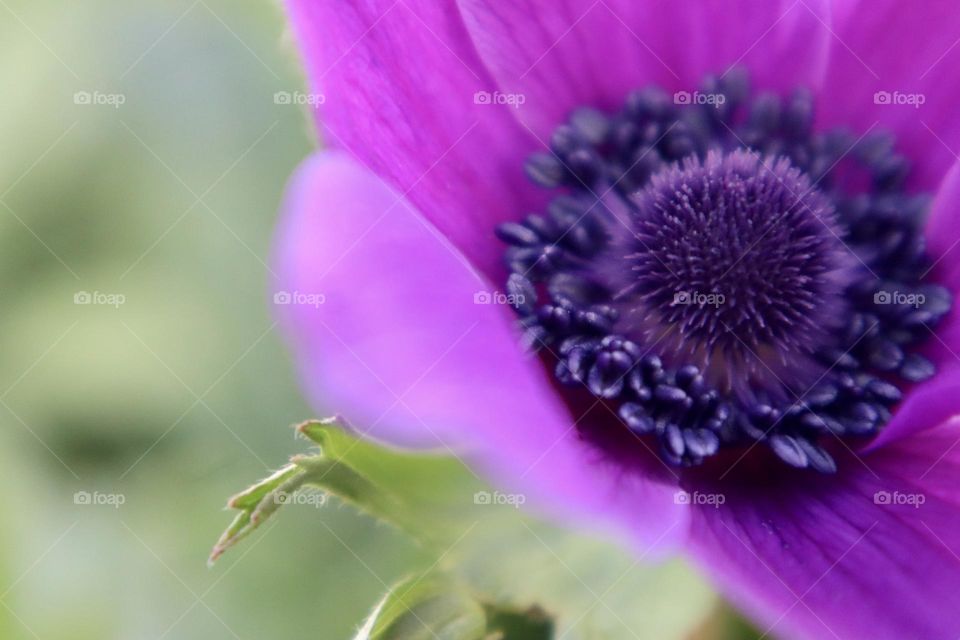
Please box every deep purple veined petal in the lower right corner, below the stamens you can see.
[693,421,960,640]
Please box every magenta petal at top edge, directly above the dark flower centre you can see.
[459,0,830,139]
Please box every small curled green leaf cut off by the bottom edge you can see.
[354,575,553,640]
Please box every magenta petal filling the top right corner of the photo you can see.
[818,0,960,189]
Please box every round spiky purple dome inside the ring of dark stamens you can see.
[607,149,855,396]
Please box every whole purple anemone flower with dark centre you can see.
[274,0,960,639]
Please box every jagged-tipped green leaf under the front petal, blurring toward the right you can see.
[214,420,718,640]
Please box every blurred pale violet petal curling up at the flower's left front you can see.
[274,152,687,547]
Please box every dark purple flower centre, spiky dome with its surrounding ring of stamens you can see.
[497,72,951,472]
